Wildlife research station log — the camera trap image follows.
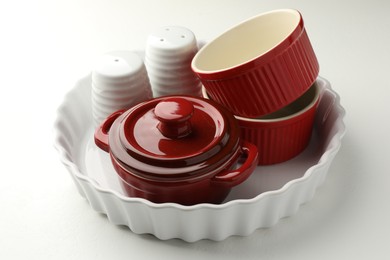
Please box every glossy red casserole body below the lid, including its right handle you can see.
[111,141,258,205]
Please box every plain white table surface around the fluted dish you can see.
[0,0,390,260]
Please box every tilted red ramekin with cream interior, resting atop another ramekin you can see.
[192,10,319,118]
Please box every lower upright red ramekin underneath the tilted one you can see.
[236,84,319,165]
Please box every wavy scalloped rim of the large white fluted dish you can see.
[54,75,346,242]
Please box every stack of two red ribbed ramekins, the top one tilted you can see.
[191,9,320,165]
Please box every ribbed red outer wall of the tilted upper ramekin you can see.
[200,28,319,118]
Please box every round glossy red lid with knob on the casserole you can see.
[110,96,239,175]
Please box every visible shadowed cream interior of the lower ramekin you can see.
[202,82,320,123]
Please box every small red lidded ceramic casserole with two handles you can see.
[95,96,258,205]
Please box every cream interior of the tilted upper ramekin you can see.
[192,9,301,73]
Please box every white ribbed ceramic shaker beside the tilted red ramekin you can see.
[145,26,201,97]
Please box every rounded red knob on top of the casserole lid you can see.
[154,97,194,139]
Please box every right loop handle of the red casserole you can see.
[211,140,259,188]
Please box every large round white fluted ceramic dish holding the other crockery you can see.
[55,75,345,242]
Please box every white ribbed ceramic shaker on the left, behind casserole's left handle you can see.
[92,51,152,127]
